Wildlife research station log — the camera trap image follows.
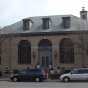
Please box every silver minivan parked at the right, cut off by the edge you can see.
[60,68,88,82]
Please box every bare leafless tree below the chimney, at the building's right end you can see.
[73,23,88,67]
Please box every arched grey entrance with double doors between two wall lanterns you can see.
[38,39,52,68]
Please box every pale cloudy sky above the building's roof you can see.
[0,0,88,27]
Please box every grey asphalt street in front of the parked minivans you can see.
[0,81,88,88]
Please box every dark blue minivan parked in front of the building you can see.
[10,69,47,82]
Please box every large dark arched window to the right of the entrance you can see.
[60,38,74,63]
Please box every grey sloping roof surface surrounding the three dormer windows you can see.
[1,15,88,34]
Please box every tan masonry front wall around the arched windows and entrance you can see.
[0,35,88,70]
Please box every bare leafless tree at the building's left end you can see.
[0,29,19,69]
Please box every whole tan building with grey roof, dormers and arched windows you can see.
[0,8,88,70]
